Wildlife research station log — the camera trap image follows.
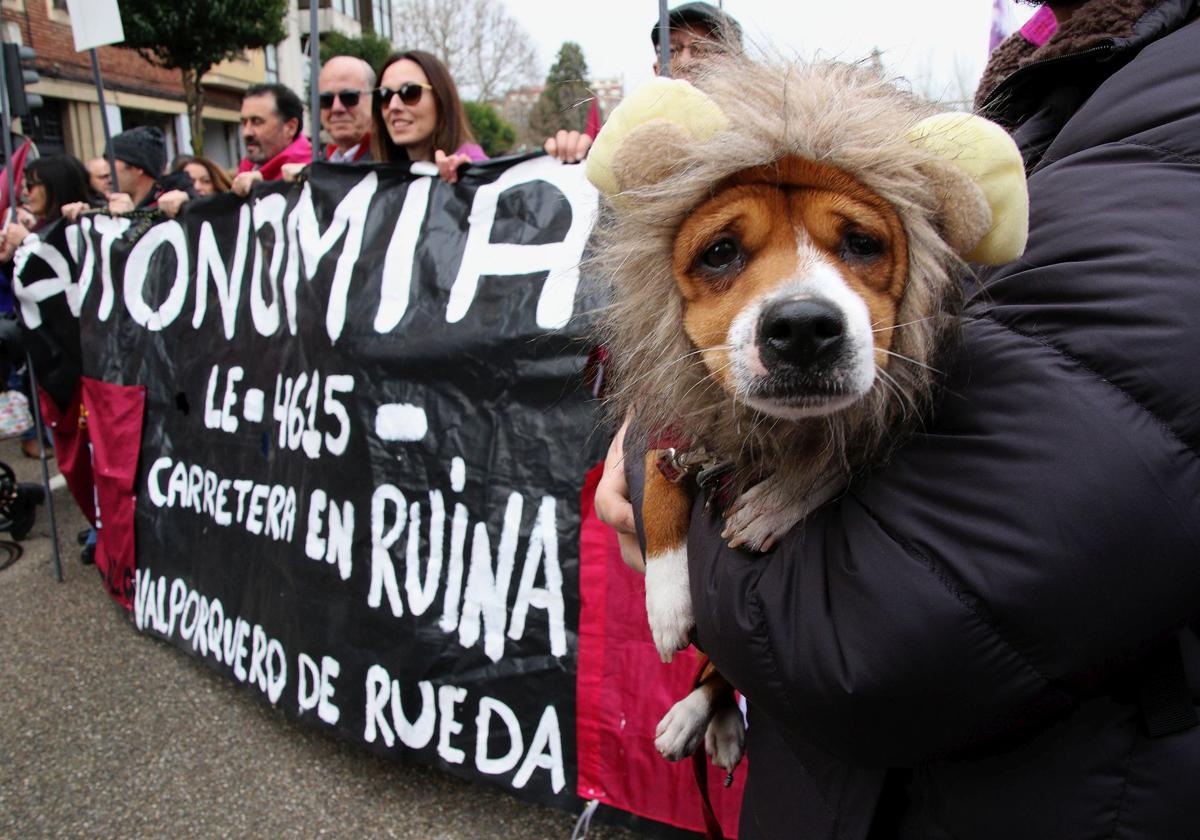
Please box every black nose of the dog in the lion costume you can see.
[758,298,846,367]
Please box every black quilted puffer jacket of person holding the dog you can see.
[689,0,1200,840]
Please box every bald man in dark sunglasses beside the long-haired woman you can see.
[317,55,376,163]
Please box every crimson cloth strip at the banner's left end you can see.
[40,377,146,610]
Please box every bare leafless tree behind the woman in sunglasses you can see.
[394,0,539,102]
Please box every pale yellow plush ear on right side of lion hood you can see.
[908,114,1030,265]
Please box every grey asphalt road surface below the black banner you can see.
[0,440,643,840]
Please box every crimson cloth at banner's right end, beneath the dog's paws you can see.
[575,466,746,838]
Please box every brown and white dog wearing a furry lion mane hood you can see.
[587,58,1028,769]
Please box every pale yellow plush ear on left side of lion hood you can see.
[587,78,730,198]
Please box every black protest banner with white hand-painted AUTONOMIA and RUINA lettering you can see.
[17,157,734,827]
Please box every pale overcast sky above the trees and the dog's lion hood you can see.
[504,0,1032,105]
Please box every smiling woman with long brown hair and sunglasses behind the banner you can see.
[373,49,487,184]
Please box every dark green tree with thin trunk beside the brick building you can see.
[119,0,288,155]
